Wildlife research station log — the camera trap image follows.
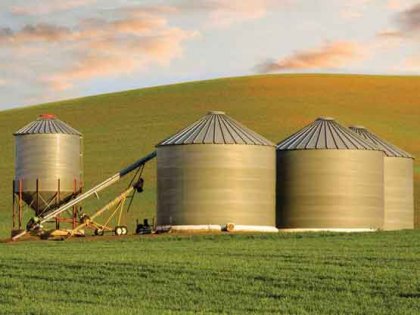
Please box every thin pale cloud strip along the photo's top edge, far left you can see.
[10,0,96,15]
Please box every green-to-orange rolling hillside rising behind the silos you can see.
[0,75,420,236]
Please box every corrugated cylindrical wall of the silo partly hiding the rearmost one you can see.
[277,150,384,229]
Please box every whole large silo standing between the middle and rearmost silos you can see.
[276,117,384,231]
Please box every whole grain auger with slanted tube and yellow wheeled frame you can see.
[12,151,156,241]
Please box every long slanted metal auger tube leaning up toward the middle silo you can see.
[12,151,156,241]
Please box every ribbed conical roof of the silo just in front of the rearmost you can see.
[277,117,378,151]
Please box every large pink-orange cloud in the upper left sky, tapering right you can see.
[38,19,198,90]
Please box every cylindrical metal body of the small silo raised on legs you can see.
[15,134,82,214]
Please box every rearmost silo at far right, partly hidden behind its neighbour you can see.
[350,126,414,230]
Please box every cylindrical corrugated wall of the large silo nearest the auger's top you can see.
[157,144,276,226]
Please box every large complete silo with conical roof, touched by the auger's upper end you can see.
[157,111,276,231]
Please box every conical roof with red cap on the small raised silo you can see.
[13,114,82,136]
